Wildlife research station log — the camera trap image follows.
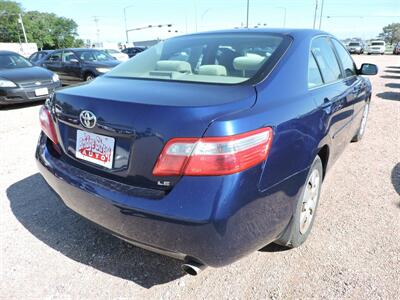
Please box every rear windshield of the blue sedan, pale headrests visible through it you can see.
[106,33,283,84]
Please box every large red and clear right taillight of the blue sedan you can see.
[153,127,273,176]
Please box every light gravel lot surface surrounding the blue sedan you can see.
[0,55,400,299]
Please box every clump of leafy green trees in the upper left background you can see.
[0,0,83,49]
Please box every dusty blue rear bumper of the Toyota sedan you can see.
[36,135,307,267]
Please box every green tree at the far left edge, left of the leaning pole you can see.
[0,0,22,43]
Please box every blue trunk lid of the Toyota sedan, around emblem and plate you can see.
[52,77,256,190]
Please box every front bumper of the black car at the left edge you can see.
[0,82,61,105]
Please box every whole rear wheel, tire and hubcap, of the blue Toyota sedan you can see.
[275,156,323,248]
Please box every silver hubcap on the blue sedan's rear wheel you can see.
[300,169,320,234]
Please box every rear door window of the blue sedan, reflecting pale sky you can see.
[311,37,343,83]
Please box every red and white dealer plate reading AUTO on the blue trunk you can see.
[75,130,115,169]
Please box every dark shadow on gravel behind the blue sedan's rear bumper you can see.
[7,173,184,288]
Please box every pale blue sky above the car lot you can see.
[17,0,400,43]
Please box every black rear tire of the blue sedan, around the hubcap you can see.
[274,155,323,248]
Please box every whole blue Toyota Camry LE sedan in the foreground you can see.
[36,29,377,275]
